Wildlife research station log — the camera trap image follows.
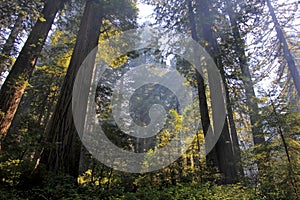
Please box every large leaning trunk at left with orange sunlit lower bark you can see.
[0,0,65,145]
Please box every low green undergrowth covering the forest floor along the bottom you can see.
[0,155,294,200]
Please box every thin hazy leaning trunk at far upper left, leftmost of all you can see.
[0,14,25,78]
